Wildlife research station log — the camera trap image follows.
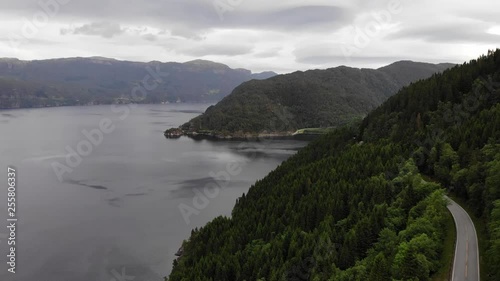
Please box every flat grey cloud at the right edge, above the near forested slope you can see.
[388,24,500,43]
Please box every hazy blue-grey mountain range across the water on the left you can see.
[0,57,276,108]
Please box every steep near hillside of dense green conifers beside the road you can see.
[168,50,500,281]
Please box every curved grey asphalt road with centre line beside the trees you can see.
[448,198,480,281]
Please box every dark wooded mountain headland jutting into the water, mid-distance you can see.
[181,61,453,136]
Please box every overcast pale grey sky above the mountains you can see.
[0,0,500,73]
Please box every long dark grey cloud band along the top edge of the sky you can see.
[0,0,355,33]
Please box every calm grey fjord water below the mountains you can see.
[0,104,306,281]
